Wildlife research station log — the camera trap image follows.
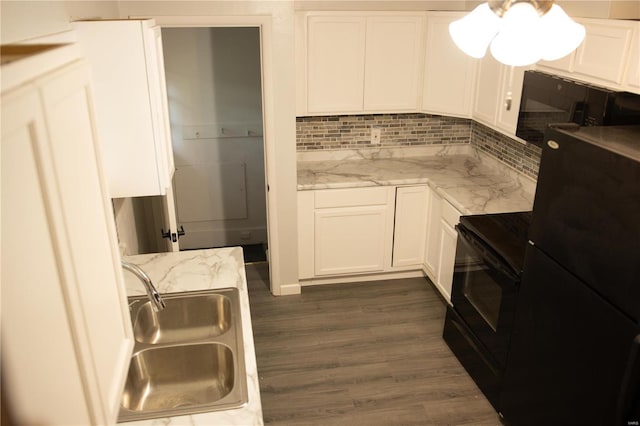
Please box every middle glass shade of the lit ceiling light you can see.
[490,3,544,66]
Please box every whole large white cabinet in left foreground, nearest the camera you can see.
[1,46,133,424]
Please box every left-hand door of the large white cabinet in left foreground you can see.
[0,83,95,424]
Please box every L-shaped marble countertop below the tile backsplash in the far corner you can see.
[298,145,535,214]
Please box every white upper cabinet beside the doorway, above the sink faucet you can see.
[73,20,174,198]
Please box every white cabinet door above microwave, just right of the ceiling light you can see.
[575,20,633,84]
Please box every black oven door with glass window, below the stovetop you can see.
[451,224,520,367]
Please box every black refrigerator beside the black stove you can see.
[499,126,640,426]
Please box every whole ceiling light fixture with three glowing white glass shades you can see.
[449,0,585,66]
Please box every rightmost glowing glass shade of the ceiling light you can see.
[540,4,585,61]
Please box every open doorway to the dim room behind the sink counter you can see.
[162,27,268,261]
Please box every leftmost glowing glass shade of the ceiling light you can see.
[449,3,500,58]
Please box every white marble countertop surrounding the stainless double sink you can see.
[121,247,263,426]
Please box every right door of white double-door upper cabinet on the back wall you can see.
[364,16,424,112]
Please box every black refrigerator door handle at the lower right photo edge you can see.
[616,334,640,425]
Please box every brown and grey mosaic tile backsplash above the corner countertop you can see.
[296,113,541,179]
